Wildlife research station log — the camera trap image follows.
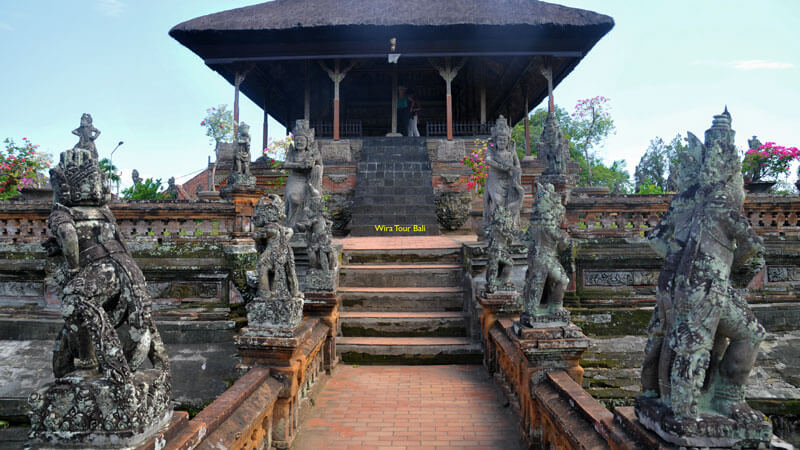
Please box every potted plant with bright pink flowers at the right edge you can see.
[742,136,800,194]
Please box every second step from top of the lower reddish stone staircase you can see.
[339,264,462,287]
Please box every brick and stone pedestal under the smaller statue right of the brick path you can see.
[509,321,589,384]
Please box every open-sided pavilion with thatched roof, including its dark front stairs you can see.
[170,0,614,235]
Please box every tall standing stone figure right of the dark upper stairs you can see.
[483,116,525,232]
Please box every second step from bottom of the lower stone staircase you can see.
[339,311,467,337]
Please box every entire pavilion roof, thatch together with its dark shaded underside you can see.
[169,0,614,134]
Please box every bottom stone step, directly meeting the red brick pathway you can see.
[336,336,483,364]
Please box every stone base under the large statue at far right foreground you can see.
[632,396,772,448]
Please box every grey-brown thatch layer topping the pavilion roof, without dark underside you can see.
[170,0,614,33]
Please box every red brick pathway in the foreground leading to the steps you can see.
[292,364,522,450]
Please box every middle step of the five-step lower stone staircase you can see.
[339,287,464,312]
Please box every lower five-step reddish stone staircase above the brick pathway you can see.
[336,241,482,364]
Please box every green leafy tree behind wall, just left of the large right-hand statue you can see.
[633,135,687,194]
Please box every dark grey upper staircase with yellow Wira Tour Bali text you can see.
[350,137,439,236]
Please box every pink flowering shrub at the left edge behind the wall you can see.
[0,138,50,200]
